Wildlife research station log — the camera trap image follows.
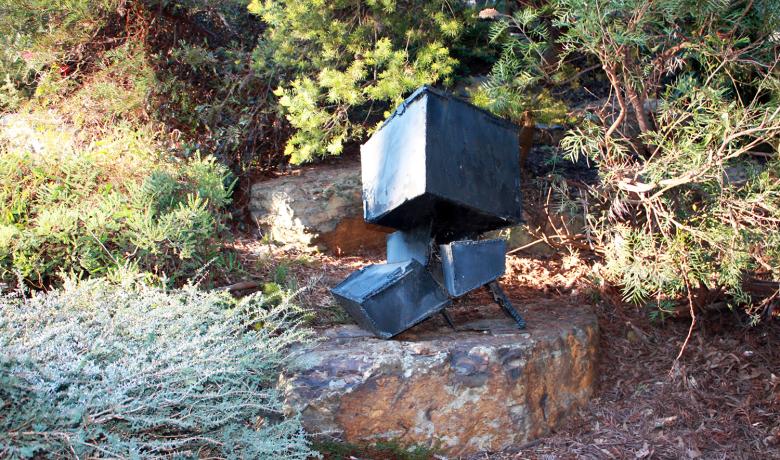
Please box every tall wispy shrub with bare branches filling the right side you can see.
[482,0,780,320]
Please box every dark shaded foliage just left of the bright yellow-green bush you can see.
[144,0,278,171]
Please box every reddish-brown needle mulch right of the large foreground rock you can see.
[484,276,780,460]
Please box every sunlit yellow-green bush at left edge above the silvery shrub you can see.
[0,113,230,287]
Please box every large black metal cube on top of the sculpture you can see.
[361,86,522,242]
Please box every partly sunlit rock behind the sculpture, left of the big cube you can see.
[249,162,390,254]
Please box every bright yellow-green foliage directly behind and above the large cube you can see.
[249,0,482,164]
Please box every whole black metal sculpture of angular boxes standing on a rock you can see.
[331,86,525,338]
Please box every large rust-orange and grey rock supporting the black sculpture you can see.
[280,304,598,455]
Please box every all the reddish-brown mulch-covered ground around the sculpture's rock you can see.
[229,241,780,460]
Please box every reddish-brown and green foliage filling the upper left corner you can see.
[0,0,284,173]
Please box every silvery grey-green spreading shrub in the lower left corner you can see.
[0,280,316,459]
